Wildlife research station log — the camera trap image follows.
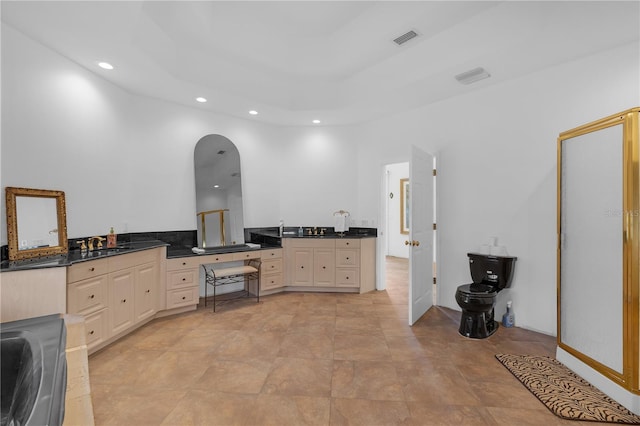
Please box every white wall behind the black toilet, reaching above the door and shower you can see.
[358,43,640,335]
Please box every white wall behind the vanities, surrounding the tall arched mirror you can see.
[0,23,358,244]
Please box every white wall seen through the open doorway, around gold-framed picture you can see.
[384,163,409,258]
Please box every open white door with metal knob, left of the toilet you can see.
[405,146,433,325]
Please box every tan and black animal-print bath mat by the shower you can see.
[496,354,640,425]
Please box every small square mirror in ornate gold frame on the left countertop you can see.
[6,187,68,261]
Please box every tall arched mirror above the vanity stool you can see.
[194,135,244,249]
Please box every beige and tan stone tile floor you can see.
[89,258,593,426]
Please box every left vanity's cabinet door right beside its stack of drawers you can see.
[109,269,135,335]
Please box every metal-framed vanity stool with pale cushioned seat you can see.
[202,259,262,312]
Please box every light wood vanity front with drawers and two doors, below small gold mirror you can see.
[67,248,164,353]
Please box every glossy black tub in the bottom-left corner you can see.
[0,315,67,426]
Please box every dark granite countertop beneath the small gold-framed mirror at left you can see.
[0,240,168,272]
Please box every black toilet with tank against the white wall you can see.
[456,253,517,339]
